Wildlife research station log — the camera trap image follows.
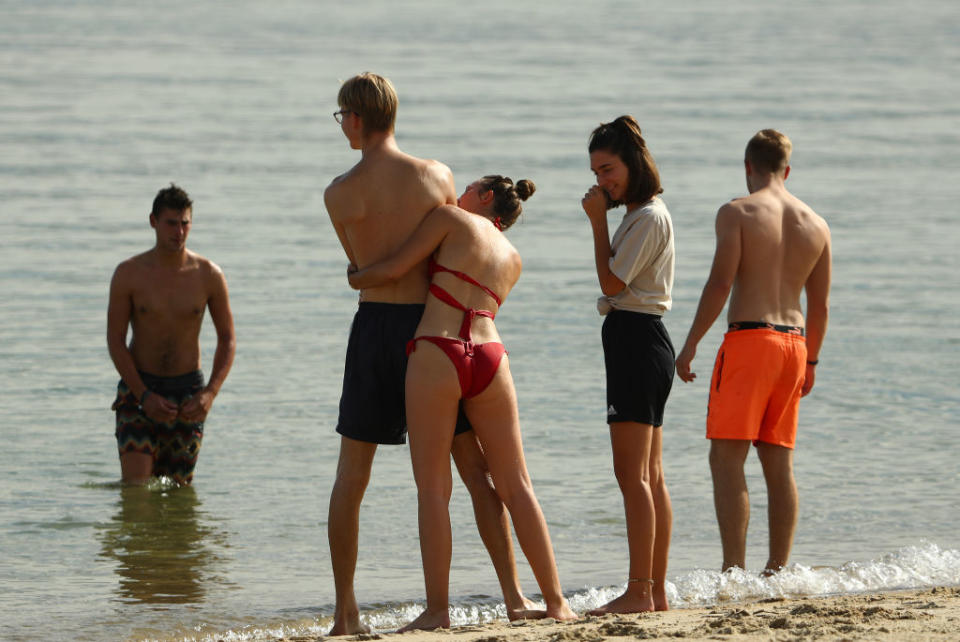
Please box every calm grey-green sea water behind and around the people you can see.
[0,0,960,640]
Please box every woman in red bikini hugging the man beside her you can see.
[349,176,576,630]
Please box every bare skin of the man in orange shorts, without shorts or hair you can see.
[676,144,831,573]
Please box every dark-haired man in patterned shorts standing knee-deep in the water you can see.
[107,184,235,485]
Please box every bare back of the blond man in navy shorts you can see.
[324,138,456,303]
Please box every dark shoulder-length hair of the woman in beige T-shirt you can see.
[589,116,663,207]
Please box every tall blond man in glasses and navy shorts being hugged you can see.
[323,73,532,635]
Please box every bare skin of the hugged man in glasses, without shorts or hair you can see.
[324,97,532,635]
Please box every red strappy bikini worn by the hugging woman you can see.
[407,259,507,399]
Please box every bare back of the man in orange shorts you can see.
[718,186,829,326]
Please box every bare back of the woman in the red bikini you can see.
[417,206,522,343]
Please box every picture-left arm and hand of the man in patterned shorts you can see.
[107,264,177,421]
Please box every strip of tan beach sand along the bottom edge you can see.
[286,587,960,642]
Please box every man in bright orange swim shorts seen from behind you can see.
[677,129,830,573]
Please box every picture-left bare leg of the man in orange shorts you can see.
[710,439,750,571]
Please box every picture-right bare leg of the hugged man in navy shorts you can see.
[452,430,533,620]
